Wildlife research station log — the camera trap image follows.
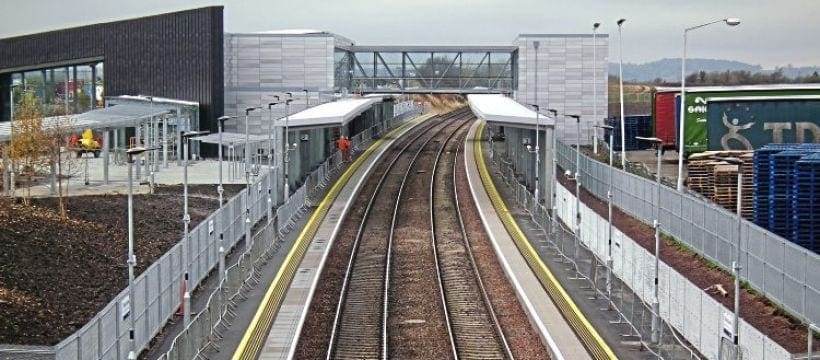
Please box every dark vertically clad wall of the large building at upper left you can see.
[0,6,224,135]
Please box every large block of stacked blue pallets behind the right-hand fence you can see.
[754,144,820,252]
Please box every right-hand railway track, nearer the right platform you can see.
[429,119,514,359]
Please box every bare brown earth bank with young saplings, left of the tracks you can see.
[0,185,241,345]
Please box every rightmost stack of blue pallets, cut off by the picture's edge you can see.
[792,152,820,252]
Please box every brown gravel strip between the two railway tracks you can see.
[387,121,462,359]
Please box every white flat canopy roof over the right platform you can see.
[467,94,555,129]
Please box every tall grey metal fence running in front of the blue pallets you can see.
[557,142,820,324]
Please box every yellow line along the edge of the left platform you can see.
[231,114,435,360]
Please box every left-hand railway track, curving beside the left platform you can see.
[326,109,468,359]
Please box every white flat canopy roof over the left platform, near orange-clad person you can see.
[276,97,382,128]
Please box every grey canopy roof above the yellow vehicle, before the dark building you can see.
[0,104,170,141]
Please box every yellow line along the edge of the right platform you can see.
[473,122,618,359]
